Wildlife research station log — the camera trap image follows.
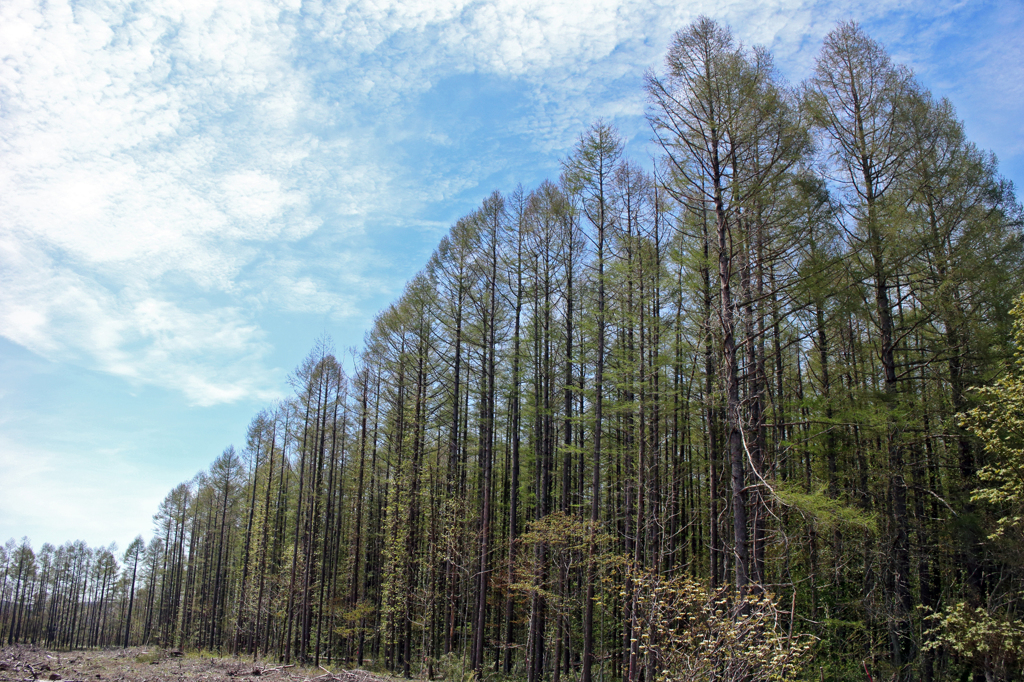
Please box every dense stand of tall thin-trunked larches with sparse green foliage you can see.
[0,18,1024,682]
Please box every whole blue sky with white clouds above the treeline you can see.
[0,0,1024,550]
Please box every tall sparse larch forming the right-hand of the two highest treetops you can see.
[807,23,919,679]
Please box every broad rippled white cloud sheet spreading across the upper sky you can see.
[0,0,1024,403]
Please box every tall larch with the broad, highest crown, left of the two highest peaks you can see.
[647,17,806,595]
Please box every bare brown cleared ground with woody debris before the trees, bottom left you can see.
[0,645,392,682]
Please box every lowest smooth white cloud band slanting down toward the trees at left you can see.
[0,233,276,406]
